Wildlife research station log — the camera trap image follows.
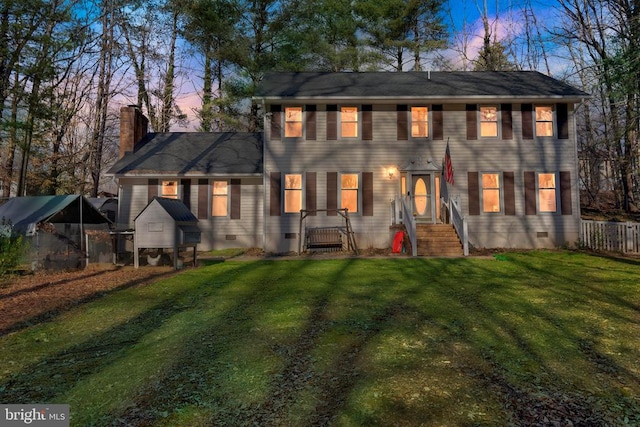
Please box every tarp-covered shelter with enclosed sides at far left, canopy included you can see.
[0,195,111,269]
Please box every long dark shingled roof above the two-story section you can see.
[255,71,589,100]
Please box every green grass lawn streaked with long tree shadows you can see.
[0,251,640,426]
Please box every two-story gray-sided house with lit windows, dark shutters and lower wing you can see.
[111,72,588,252]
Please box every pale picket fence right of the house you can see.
[580,220,640,254]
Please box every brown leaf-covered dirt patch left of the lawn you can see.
[0,264,176,335]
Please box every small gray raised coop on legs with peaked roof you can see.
[133,197,200,269]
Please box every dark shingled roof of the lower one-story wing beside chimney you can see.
[108,132,263,175]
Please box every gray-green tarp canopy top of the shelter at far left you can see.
[0,195,110,236]
